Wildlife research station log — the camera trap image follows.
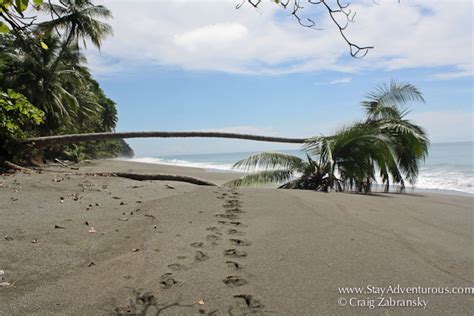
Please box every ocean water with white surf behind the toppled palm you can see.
[124,142,474,194]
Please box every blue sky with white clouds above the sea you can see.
[86,0,473,157]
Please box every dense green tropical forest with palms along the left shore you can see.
[0,0,133,162]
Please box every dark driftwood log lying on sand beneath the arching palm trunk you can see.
[72,172,216,187]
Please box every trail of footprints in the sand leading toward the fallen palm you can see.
[160,190,263,314]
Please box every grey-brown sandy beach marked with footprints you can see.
[0,160,474,315]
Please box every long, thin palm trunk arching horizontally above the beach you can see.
[21,132,306,147]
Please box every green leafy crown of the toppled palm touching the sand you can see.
[227,82,429,192]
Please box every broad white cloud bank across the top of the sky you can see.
[88,0,473,79]
